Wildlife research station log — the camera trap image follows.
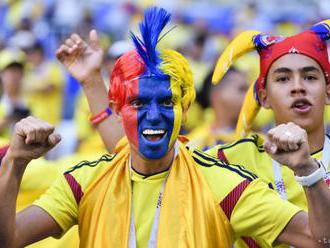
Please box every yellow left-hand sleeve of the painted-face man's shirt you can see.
[33,174,78,235]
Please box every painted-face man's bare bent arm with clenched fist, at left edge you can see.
[0,117,60,247]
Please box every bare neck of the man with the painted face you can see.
[131,146,174,176]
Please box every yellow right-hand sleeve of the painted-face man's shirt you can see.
[230,179,301,246]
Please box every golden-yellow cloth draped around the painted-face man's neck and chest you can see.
[36,142,232,247]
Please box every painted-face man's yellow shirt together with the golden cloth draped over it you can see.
[34,139,299,247]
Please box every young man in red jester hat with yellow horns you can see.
[209,20,330,247]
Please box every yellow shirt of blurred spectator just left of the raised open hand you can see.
[22,62,64,125]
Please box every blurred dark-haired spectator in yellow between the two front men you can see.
[188,68,248,150]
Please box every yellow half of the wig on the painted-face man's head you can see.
[160,49,196,110]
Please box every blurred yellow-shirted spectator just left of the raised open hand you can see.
[23,42,64,125]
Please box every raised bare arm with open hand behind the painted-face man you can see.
[56,30,124,152]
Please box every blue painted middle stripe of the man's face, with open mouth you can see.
[136,77,175,159]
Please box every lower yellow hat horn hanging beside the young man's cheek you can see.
[235,84,260,139]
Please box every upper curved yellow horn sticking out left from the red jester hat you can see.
[212,31,260,84]
